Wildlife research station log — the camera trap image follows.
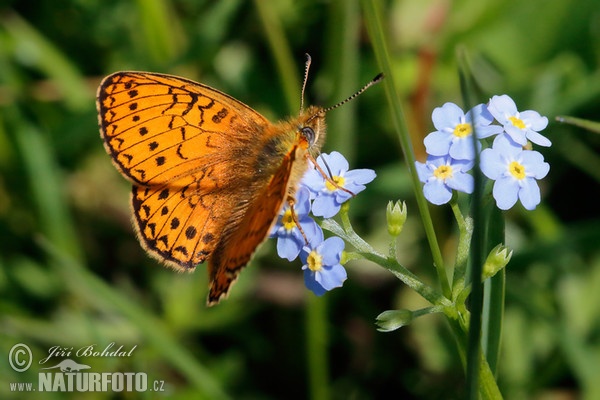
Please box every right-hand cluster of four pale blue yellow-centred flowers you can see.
[415,95,552,210]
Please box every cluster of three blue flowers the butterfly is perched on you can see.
[270,151,375,296]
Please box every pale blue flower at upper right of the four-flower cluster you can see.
[488,94,552,147]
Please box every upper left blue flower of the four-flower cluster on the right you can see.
[424,103,502,160]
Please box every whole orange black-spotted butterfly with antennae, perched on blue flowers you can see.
[97,57,382,305]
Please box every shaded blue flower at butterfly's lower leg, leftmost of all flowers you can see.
[270,186,323,261]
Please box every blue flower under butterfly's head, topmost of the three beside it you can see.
[302,151,376,218]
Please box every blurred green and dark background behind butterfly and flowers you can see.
[0,0,600,399]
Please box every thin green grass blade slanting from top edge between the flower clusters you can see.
[361,0,452,298]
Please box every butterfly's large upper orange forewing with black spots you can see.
[98,72,268,185]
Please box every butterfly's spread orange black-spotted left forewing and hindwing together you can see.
[97,72,269,269]
